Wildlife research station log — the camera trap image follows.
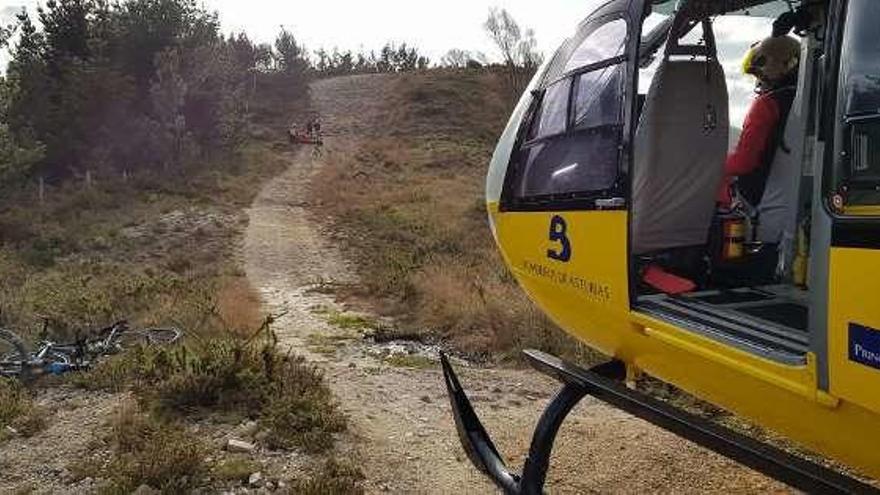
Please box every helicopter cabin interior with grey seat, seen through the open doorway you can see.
[630,2,824,364]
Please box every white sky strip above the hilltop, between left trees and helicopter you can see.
[205,0,601,59]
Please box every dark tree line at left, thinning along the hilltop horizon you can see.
[0,0,540,186]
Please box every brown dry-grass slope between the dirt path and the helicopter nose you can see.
[313,72,582,357]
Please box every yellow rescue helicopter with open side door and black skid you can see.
[441,0,880,493]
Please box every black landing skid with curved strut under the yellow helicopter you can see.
[440,351,880,495]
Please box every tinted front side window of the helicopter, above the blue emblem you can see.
[504,18,627,209]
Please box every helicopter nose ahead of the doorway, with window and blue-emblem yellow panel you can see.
[487,0,645,350]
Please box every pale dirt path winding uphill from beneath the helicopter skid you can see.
[244,76,784,493]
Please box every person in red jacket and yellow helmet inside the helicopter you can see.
[718,36,800,208]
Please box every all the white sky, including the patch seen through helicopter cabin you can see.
[0,0,770,125]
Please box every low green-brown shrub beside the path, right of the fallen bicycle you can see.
[76,340,346,452]
